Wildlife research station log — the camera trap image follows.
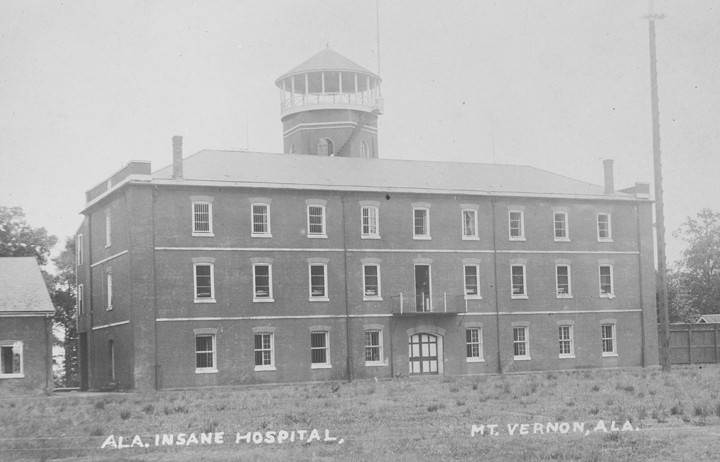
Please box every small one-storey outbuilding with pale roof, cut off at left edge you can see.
[0,257,55,395]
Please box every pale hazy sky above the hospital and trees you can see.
[0,0,720,262]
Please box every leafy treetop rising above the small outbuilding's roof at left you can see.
[0,206,57,265]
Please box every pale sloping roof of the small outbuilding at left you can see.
[0,257,55,316]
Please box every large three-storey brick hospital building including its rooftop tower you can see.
[77,50,658,389]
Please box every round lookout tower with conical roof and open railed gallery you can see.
[275,48,383,158]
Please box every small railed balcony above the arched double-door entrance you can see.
[390,292,469,317]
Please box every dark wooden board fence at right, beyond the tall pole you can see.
[670,324,720,364]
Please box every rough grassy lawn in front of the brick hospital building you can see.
[0,365,720,461]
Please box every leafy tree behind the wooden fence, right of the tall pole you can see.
[674,209,720,322]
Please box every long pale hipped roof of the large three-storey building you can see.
[152,150,635,199]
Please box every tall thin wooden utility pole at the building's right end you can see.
[647,0,670,371]
